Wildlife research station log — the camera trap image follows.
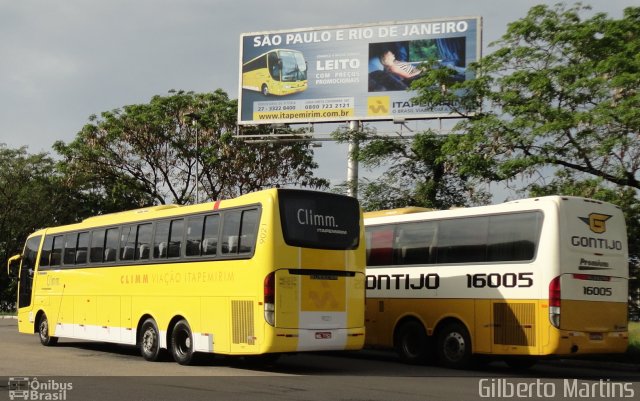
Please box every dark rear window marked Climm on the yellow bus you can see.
[278,189,360,250]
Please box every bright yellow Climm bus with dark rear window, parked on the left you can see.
[8,189,365,364]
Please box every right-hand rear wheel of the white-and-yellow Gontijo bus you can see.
[436,323,471,369]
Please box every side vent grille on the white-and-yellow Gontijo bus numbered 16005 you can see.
[493,302,536,347]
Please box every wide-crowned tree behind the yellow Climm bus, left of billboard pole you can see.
[54,90,327,204]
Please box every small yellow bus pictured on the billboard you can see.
[242,49,307,96]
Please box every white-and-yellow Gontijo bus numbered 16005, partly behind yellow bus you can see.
[364,196,628,368]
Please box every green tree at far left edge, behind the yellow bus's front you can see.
[0,144,148,310]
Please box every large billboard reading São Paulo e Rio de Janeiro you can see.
[238,17,482,124]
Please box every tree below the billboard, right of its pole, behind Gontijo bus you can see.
[334,128,488,210]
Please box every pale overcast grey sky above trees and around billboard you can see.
[0,0,637,198]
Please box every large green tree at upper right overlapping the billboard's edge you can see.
[413,4,640,189]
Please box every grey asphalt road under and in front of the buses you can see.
[0,319,640,401]
